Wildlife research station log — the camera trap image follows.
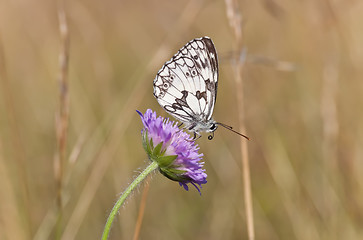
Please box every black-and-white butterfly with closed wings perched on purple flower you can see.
[153,37,248,140]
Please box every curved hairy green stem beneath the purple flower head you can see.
[102,161,158,240]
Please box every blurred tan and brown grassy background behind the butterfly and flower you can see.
[0,0,363,240]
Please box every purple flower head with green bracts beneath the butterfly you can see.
[137,109,207,193]
